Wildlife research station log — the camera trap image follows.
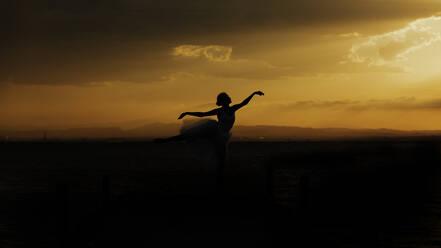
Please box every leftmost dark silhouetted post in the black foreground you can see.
[56,184,70,248]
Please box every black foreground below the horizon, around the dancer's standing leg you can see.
[0,138,441,248]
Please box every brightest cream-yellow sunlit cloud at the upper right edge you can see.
[343,16,441,68]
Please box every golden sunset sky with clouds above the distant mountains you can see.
[0,0,441,130]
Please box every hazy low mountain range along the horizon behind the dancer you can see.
[0,123,441,140]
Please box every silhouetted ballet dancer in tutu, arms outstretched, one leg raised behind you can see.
[155,91,264,191]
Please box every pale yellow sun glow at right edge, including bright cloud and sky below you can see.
[342,16,441,80]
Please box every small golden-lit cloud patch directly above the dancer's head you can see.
[172,45,233,62]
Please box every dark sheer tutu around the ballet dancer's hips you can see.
[180,119,231,160]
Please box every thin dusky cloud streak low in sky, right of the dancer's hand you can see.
[278,97,441,112]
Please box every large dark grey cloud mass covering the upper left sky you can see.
[0,0,439,84]
